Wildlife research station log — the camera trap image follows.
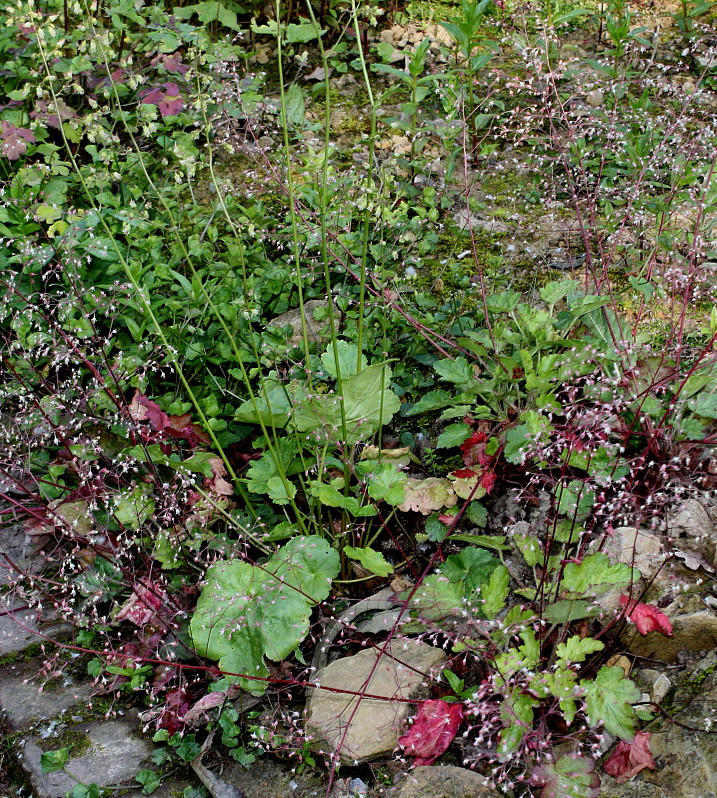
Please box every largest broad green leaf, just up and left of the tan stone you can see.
[190,536,340,695]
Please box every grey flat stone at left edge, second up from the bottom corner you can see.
[0,662,92,731]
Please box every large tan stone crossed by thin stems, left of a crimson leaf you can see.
[307,640,446,764]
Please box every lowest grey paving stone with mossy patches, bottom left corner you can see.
[21,720,154,798]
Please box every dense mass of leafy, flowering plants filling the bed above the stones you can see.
[0,0,717,798]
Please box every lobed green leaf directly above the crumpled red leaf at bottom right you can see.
[580,665,641,741]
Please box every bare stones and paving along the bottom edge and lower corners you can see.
[0,490,717,798]
